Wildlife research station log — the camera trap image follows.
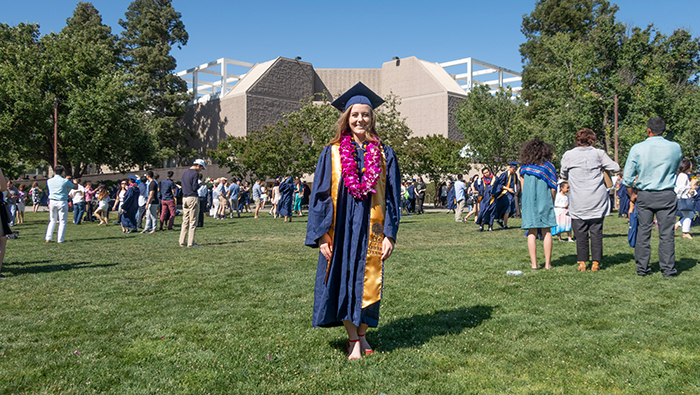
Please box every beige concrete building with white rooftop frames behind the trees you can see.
[178,57,520,162]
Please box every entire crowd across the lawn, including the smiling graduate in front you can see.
[0,83,700,360]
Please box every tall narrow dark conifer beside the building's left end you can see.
[119,0,195,164]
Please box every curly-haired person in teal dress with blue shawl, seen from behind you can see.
[520,139,557,270]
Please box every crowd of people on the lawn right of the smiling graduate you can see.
[432,117,688,277]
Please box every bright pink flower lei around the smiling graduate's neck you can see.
[340,133,382,200]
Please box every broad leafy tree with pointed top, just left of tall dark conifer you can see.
[53,2,155,177]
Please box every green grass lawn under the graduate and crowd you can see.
[0,212,700,395]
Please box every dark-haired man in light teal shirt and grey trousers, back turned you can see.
[622,117,682,277]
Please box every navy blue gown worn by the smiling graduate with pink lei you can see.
[305,145,401,327]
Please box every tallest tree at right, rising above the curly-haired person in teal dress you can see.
[520,0,625,157]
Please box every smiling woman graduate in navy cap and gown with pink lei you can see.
[306,83,401,360]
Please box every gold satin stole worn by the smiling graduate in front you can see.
[326,144,386,309]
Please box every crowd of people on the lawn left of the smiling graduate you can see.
[0,159,310,251]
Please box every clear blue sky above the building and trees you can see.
[5,0,700,75]
